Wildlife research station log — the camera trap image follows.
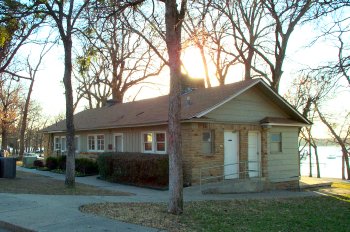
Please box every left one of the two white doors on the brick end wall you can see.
[224,131,239,179]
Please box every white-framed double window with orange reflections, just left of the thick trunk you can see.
[142,132,166,153]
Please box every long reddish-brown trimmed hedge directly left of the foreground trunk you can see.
[97,153,169,187]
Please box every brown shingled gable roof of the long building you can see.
[43,79,310,133]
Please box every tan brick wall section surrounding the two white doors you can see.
[182,123,267,184]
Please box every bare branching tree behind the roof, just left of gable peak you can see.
[214,0,272,83]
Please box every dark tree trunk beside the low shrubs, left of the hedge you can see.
[62,37,75,187]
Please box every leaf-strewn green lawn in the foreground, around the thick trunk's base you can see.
[80,184,350,232]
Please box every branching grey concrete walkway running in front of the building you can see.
[0,167,315,232]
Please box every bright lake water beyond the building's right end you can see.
[300,146,347,178]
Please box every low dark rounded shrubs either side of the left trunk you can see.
[46,156,98,175]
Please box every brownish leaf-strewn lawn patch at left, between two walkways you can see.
[0,171,131,196]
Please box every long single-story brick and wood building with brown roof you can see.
[44,79,310,190]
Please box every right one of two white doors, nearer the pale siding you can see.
[248,131,261,177]
